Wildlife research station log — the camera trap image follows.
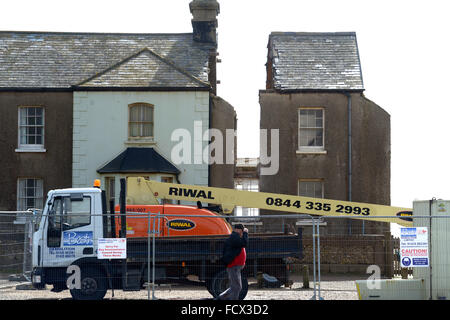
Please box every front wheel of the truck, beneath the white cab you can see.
[70,267,107,300]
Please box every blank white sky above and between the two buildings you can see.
[0,0,450,207]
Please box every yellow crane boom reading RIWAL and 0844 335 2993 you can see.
[127,177,412,227]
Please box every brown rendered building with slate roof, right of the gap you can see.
[259,32,391,234]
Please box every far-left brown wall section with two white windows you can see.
[0,89,72,211]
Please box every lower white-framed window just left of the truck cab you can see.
[17,178,44,211]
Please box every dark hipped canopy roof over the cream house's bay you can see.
[97,148,180,174]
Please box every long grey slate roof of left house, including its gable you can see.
[0,31,214,89]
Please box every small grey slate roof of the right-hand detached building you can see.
[268,32,364,91]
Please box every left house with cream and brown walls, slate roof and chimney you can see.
[0,0,236,210]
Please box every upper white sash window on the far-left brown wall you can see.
[16,107,45,152]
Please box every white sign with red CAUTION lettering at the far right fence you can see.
[400,227,430,268]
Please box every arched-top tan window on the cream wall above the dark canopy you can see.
[128,103,153,139]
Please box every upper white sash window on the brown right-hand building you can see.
[298,108,325,152]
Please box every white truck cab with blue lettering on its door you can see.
[32,188,103,291]
